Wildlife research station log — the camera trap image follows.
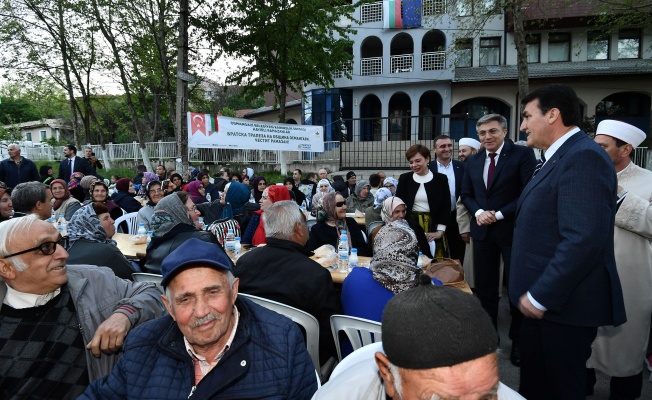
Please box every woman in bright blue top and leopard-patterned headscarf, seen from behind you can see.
[341,219,423,322]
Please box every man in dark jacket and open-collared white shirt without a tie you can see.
[430,135,466,264]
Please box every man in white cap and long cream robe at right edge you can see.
[587,120,652,399]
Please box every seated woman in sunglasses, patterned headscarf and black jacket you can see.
[306,192,371,256]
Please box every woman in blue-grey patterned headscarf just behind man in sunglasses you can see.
[67,202,136,279]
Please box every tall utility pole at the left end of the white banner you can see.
[176,0,188,173]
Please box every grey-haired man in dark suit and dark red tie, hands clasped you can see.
[462,114,536,366]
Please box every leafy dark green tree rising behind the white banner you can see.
[191,0,359,121]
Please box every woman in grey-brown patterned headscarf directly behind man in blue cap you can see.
[145,192,219,274]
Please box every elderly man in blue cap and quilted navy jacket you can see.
[80,239,317,399]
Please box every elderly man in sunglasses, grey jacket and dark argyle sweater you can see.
[0,215,164,399]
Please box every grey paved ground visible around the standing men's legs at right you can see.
[498,294,652,400]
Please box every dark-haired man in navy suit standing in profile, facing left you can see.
[509,85,626,400]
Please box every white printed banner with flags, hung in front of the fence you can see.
[188,112,324,152]
